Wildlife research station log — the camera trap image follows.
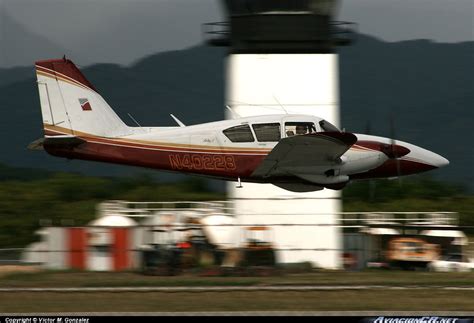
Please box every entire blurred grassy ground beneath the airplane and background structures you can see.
[0,270,474,313]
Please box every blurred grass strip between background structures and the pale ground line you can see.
[0,270,474,287]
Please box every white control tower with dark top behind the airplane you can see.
[204,0,354,268]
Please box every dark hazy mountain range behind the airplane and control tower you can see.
[0,34,474,189]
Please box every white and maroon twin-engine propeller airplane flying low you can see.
[29,57,449,192]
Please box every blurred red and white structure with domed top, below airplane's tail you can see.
[22,215,138,271]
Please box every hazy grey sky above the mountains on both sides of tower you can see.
[0,0,474,64]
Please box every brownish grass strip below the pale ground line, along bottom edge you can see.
[0,289,474,313]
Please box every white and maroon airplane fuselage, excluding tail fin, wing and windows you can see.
[45,115,449,188]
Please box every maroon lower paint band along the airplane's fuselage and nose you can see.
[41,129,436,180]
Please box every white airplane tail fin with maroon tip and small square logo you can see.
[36,58,130,137]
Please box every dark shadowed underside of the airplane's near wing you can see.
[252,132,357,182]
